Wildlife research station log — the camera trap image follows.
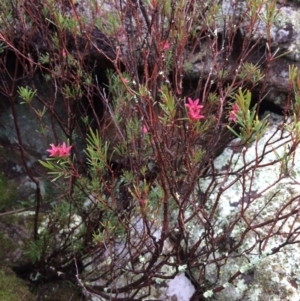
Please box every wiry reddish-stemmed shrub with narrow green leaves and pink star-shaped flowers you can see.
[0,0,299,300]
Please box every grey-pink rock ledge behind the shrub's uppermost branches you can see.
[4,0,300,107]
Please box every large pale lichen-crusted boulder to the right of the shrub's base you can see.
[198,113,300,301]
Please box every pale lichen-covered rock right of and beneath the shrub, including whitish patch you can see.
[81,114,300,301]
